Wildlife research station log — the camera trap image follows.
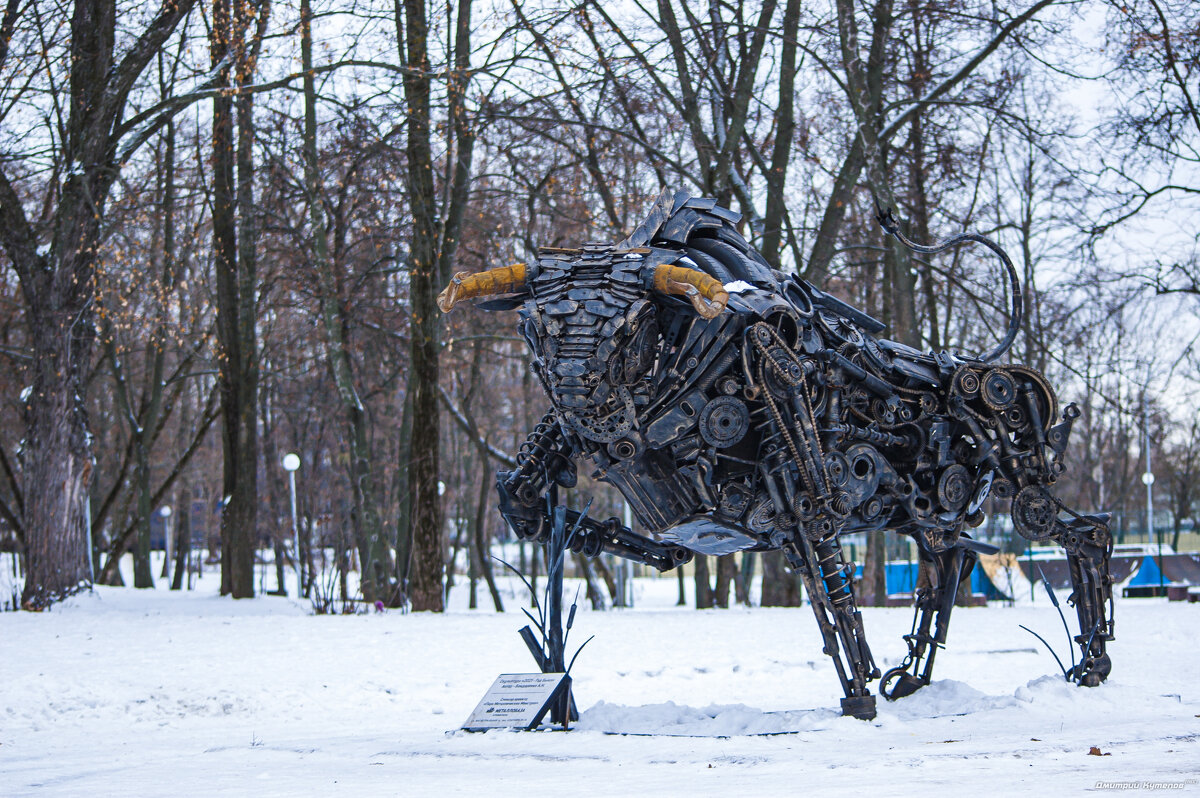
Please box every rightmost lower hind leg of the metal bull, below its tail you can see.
[1050,514,1112,688]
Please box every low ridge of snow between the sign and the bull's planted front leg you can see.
[576,701,839,737]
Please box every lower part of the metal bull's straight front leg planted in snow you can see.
[782,530,880,720]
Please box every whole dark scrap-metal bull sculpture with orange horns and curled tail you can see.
[438,192,1112,718]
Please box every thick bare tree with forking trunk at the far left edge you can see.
[0,0,194,607]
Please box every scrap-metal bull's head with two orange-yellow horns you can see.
[438,255,730,429]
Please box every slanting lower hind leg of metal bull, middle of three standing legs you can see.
[880,535,992,701]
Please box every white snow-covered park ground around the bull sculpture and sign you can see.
[0,564,1200,797]
